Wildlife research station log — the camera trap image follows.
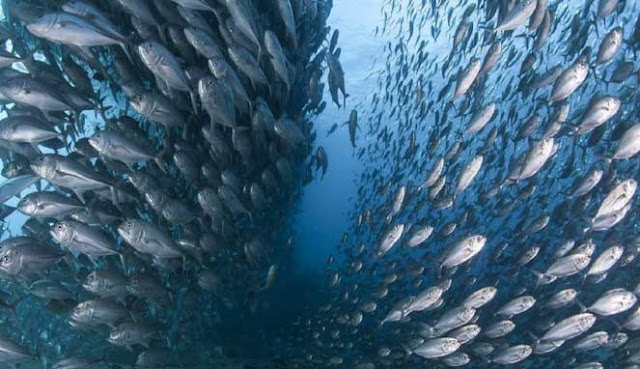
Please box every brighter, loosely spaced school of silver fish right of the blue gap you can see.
[297,0,640,369]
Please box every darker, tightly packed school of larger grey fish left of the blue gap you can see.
[0,0,346,369]
